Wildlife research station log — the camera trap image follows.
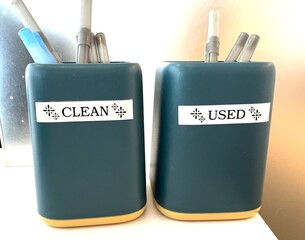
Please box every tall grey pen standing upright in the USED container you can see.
[205,10,220,62]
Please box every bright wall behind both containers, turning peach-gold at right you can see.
[2,0,305,239]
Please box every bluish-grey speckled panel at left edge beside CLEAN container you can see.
[0,3,33,165]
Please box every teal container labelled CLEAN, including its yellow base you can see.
[26,63,146,227]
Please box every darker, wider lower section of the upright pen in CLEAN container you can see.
[77,28,91,63]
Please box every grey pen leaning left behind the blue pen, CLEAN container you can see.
[11,0,62,63]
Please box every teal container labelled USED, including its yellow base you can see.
[151,62,275,220]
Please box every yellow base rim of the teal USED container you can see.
[155,201,261,221]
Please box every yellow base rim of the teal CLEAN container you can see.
[40,207,145,228]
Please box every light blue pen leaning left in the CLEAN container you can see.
[18,28,57,64]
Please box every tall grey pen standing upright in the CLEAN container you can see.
[76,0,92,63]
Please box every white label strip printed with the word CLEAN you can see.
[35,100,133,123]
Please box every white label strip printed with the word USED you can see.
[178,103,270,125]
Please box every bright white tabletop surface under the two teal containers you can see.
[0,166,277,240]
